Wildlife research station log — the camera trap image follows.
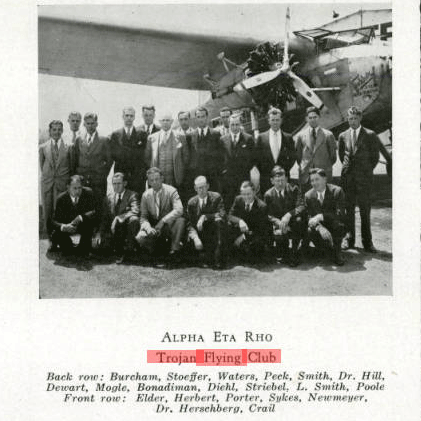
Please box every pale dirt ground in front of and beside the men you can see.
[39,166,393,298]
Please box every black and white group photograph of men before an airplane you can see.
[38,3,393,299]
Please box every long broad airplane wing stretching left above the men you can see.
[38,17,259,90]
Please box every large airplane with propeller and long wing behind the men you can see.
[38,7,392,173]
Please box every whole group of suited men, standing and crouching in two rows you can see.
[39,106,380,267]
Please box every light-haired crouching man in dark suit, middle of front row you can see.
[187,176,226,268]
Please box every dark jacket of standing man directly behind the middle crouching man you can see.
[190,127,224,176]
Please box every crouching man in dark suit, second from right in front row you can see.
[264,166,305,267]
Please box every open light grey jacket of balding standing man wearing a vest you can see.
[145,130,189,186]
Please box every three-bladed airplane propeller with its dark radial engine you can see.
[234,7,323,108]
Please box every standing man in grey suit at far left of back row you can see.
[39,120,72,251]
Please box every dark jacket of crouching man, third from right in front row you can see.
[228,196,270,237]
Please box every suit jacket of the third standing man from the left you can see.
[74,132,112,182]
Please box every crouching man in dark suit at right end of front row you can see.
[304,168,345,266]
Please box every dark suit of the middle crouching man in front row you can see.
[187,191,226,263]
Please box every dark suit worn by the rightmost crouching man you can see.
[304,184,345,252]
